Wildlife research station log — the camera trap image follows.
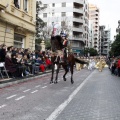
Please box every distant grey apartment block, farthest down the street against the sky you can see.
[99,26,111,55]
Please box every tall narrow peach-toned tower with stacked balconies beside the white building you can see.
[89,4,100,52]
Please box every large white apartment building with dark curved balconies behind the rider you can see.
[40,0,88,54]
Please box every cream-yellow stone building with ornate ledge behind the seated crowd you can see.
[0,0,36,50]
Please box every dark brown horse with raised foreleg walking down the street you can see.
[50,35,87,84]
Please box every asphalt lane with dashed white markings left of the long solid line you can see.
[0,70,91,120]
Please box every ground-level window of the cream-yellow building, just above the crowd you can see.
[14,34,24,48]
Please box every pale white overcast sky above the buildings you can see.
[88,0,120,41]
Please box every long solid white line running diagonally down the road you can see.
[46,72,95,120]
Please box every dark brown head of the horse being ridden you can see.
[51,35,63,51]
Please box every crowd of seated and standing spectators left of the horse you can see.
[0,44,51,77]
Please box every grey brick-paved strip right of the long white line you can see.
[57,68,120,120]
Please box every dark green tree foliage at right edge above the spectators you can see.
[109,34,120,57]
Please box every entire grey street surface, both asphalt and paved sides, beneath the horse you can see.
[0,68,120,120]
